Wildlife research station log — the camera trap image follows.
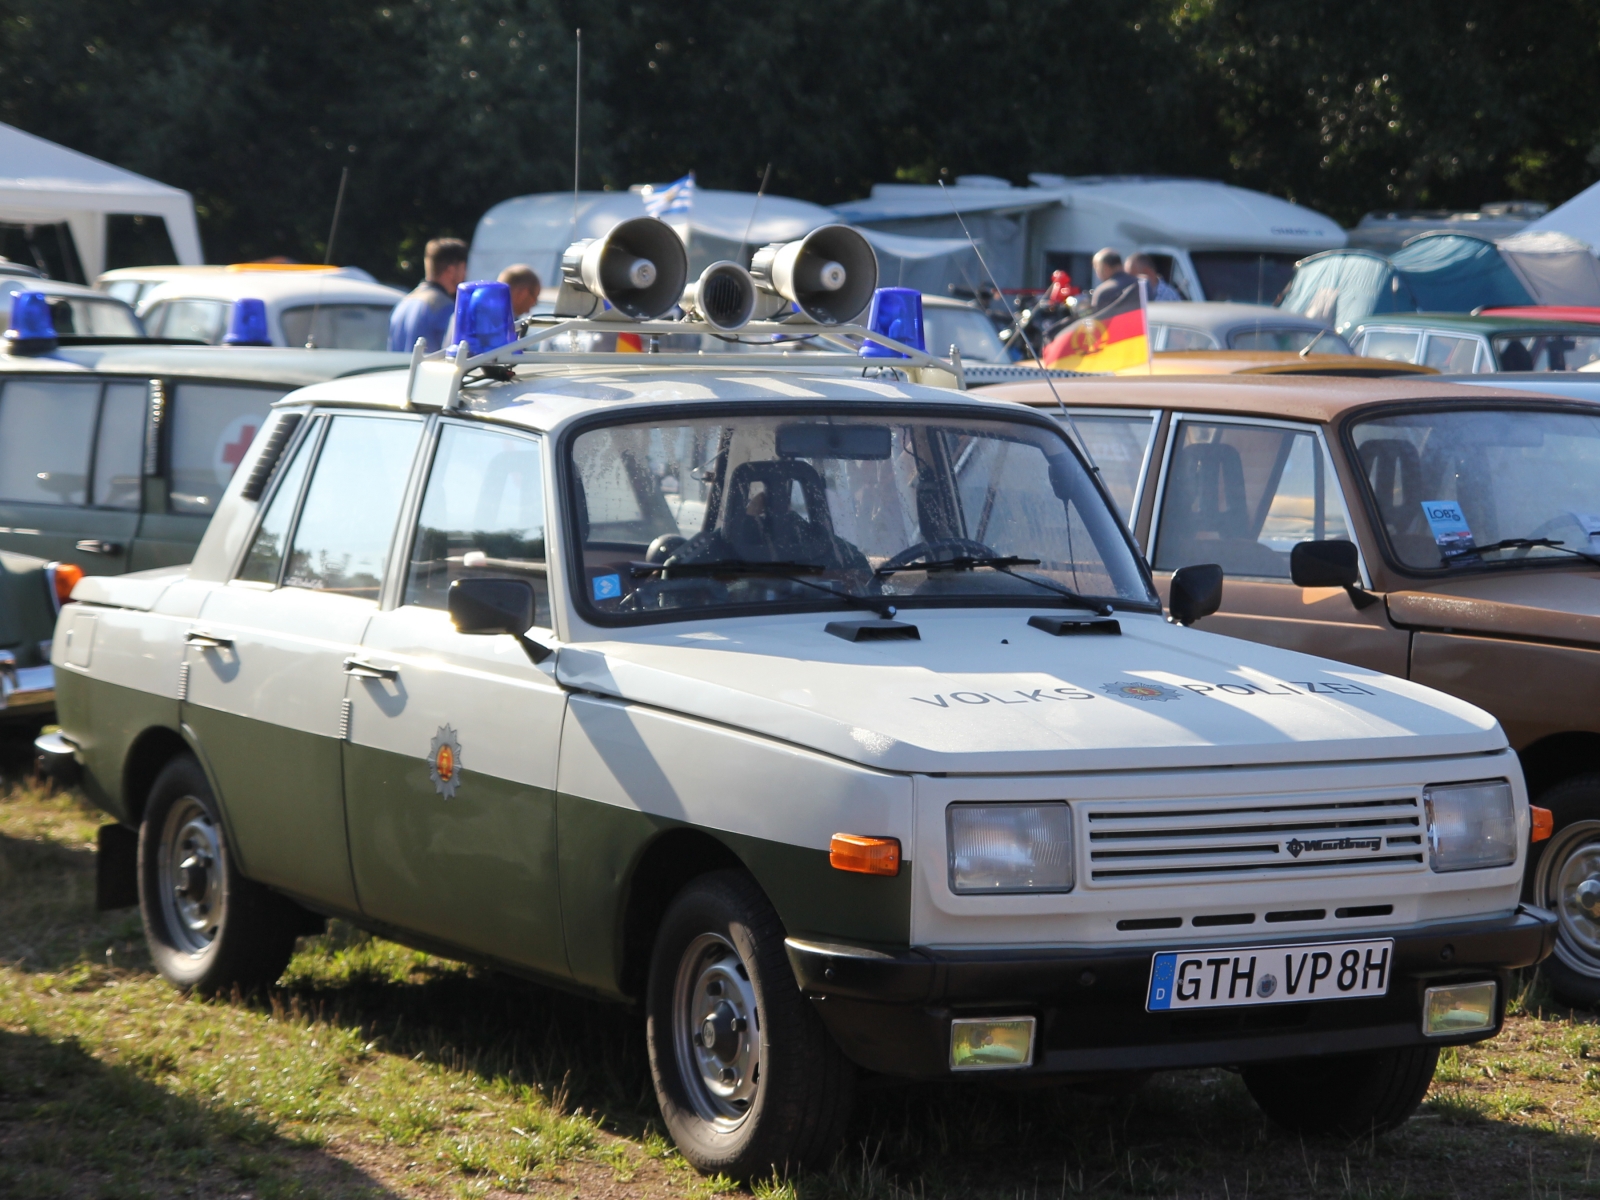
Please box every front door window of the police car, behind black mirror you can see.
[405,424,550,626]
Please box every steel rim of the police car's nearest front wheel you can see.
[672,933,762,1130]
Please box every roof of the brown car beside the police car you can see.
[984,374,1574,422]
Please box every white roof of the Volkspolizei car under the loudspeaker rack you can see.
[278,361,1036,432]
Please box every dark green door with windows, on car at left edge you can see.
[0,376,149,574]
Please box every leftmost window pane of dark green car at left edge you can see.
[0,379,101,504]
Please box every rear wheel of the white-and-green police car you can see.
[139,755,306,995]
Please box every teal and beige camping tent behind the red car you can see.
[1282,232,1600,333]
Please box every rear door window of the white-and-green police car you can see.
[283,416,422,600]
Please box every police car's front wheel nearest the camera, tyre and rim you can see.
[645,870,854,1182]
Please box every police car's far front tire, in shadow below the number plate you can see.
[1240,1046,1438,1138]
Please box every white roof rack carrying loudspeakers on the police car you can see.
[405,317,966,408]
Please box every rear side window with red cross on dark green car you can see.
[166,384,286,515]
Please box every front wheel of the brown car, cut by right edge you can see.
[1528,774,1600,1008]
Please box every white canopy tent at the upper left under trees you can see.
[0,125,205,282]
